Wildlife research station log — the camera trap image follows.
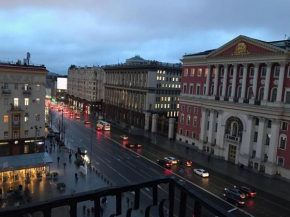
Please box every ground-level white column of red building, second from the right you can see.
[256,117,267,166]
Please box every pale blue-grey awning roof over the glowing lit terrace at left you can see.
[0,152,52,172]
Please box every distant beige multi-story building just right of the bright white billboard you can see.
[67,65,105,113]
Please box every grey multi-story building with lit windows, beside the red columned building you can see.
[104,56,182,137]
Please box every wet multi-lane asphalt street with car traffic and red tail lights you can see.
[53,111,290,217]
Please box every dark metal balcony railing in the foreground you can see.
[0,177,240,217]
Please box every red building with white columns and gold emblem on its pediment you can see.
[177,36,290,179]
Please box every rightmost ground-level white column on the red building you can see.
[265,118,281,175]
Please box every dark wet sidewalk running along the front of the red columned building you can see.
[115,120,290,201]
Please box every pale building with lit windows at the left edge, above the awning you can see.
[0,63,48,156]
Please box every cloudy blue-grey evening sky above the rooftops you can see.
[0,0,290,74]
